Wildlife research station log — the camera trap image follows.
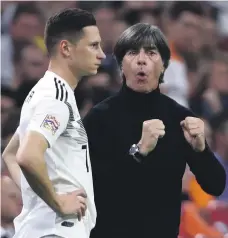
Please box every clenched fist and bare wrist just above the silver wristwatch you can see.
[138,119,165,155]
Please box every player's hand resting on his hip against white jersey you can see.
[57,190,87,221]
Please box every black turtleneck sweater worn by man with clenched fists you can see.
[84,83,225,238]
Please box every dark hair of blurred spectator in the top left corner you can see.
[12,3,43,23]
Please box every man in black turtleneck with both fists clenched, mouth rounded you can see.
[84,23,225,238]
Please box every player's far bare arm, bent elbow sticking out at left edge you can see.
[2,132,21,189]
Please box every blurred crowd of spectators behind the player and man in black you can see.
[1,1,228,238]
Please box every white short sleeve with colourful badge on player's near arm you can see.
[27,99,70,148]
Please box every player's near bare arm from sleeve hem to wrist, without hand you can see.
[16,131,61,213]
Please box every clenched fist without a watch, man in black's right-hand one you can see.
[180,117,205,152]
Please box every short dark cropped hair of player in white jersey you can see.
[44,8,96,54]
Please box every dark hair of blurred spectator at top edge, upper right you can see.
[168,1,204,20]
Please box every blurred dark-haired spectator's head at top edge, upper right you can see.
[167,1,204,56]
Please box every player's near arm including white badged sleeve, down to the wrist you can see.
[16,98,69,214]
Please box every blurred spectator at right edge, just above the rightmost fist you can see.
[190,51,228,119]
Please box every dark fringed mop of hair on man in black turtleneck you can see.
[114,23,170,83]
